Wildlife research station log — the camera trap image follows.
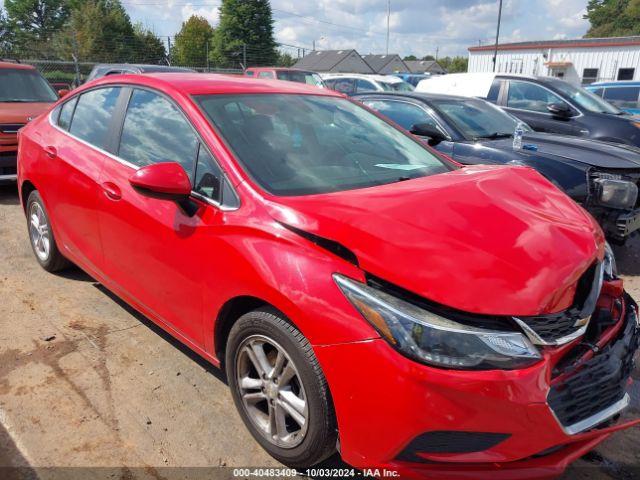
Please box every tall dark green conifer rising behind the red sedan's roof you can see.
[211,0,278,68]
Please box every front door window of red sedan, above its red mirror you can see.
[118,89,199,177]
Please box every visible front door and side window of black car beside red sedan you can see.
[363,97,453,155]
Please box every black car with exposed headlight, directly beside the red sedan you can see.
[354,93,640,243]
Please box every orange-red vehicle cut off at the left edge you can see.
[0,61,58,184]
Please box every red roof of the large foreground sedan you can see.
[90,72,344,98]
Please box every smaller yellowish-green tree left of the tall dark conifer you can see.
[171,15,214,67]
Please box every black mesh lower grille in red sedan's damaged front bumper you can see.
[547,300,640,427]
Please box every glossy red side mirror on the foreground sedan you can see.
[129,162,191,202]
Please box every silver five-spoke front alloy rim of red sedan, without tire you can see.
[236,335,309,448]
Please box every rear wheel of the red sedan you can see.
[27,190,71,272]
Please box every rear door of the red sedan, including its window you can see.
[43,87,122,273]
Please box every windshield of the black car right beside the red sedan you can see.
[431,98,531,139]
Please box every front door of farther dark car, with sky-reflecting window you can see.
[502,80,580,135]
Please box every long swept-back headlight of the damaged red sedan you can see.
[334,274,541,370]
